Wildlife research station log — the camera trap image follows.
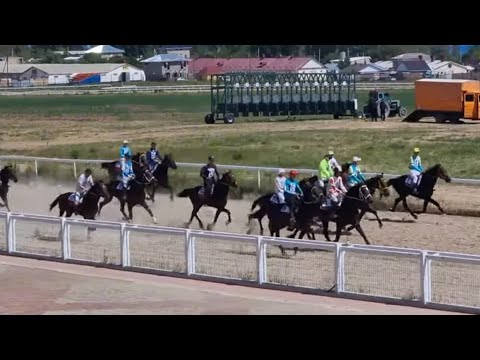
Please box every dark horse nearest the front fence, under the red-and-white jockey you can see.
[318,184,376,245]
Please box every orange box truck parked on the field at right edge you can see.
[403,79,480,123]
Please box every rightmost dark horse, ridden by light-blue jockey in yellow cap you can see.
[387,164,452,219]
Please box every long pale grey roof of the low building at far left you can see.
[0,64,135,75]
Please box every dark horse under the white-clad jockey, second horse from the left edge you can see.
[49,181,109,237]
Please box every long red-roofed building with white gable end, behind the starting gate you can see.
[189,56,327,79]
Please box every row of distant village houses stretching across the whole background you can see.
[0,45,478,87]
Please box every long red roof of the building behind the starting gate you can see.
[190,57,313,73]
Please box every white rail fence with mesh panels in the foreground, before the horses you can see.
[0,212,480,314]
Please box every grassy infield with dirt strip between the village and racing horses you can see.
[0,90,480,186]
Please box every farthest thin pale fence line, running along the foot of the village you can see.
[0,82,414,96]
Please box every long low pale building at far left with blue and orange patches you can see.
[0,64,145,85]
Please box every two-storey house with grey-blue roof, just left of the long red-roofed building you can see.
[142,54,190,81]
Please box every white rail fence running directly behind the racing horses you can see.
[0,155,480,189]
